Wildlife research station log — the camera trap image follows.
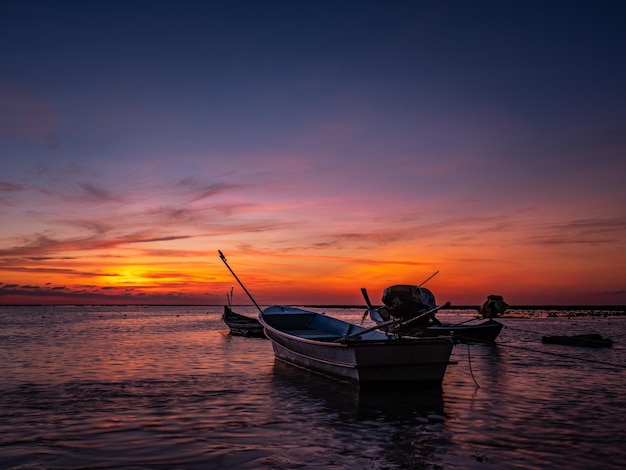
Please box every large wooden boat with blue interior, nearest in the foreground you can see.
[259,306,454,386]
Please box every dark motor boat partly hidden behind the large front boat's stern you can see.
[361,285,506,343]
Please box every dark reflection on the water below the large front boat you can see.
[274,361,445,468]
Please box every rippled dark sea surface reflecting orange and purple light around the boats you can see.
[0,306,626,469]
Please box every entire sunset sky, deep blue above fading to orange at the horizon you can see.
[0,0,626,305]
